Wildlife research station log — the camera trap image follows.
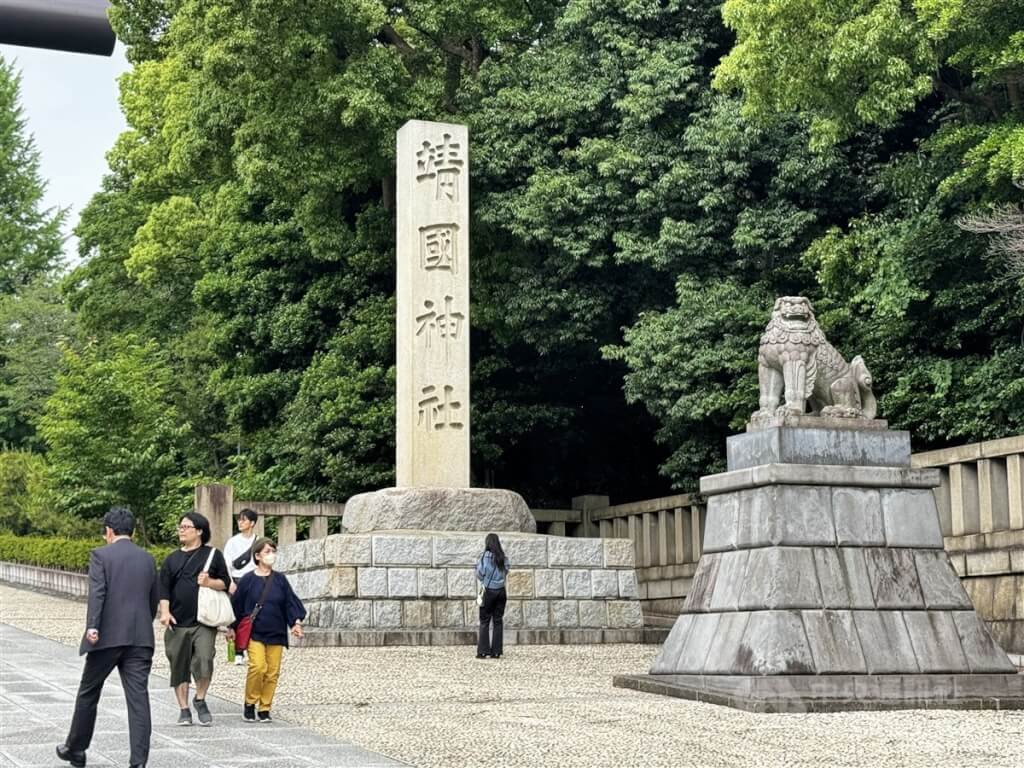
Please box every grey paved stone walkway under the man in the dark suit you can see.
[0,624,407,768]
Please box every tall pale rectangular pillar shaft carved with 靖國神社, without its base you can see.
[395,120,470,487]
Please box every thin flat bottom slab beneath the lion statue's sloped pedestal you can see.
[613,674,1024,713]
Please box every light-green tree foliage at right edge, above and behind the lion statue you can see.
[718,0,1024,445]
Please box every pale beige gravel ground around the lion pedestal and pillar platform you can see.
[0,586,1024,768]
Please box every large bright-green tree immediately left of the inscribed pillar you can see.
[68,0,569,505]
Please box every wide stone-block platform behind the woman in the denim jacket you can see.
[276,532,647,645]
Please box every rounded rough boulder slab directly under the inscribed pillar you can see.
[342,487,537,534]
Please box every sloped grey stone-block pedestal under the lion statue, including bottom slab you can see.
[615,419,1024,712]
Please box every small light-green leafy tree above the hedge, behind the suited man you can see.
[39,335,189,542]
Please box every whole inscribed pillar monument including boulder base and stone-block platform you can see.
[276,121,644,645]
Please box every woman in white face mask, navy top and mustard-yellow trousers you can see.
[231,539,306,723]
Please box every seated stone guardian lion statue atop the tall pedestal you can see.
[751,296,878,423]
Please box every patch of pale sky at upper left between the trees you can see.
[0,43,129,263]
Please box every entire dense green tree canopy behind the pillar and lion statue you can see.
[0,0,1024,536]
